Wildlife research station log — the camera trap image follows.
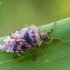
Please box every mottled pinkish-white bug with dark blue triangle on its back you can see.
[0,22,68,58]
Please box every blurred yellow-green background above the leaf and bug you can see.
[0,0,70,37]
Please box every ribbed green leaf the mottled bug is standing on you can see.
[0,18,70,70]
